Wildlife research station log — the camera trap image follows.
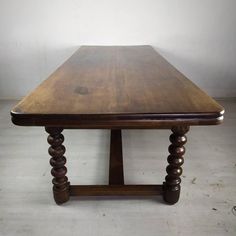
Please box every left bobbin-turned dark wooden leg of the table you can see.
[45,127,69,204]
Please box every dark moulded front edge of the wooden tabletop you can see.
[11,109,224,129]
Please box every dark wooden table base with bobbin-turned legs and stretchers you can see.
[45,126,189,204]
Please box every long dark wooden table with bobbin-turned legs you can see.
[11,46,224,204]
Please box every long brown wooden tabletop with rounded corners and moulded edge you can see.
[11,46,224,128]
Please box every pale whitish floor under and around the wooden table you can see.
[0,101,236,236]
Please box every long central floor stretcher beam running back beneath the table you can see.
[109,130,124,185]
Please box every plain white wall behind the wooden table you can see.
[0,0,236,98]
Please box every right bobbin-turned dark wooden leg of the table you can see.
[163,126,189,204]
